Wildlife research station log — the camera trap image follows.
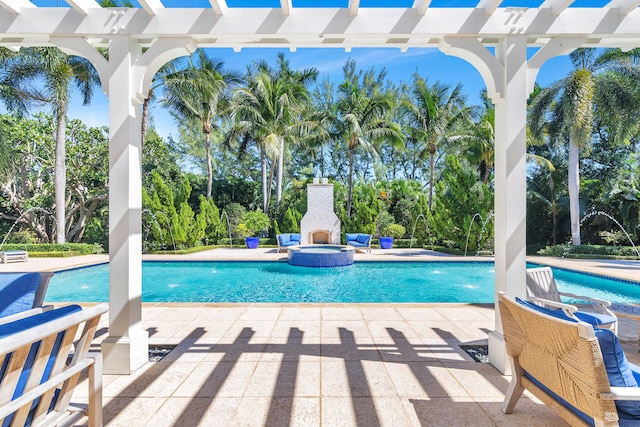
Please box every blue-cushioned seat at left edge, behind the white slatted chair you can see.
[0,272,53,319]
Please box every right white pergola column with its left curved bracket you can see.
[440,35,529,372]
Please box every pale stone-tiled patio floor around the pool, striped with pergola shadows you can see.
[0,249,640,427]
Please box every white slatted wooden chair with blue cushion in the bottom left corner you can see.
[0,304,108,427]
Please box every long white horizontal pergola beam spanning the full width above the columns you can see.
[0,7,640,48]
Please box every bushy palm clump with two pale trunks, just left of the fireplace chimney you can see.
[230,54,318,212]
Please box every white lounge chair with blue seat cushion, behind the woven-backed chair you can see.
[527,267,618,333]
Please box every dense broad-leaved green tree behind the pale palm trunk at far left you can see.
[0,113,109,243]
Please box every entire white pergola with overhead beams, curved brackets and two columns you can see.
[0,0,640,374]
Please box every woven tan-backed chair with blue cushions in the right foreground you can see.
[498,292,640,426]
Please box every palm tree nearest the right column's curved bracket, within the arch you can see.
[402,74,470,209]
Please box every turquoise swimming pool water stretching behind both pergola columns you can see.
[45,261,640,303]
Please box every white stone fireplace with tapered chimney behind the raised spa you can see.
[300,178,340,245]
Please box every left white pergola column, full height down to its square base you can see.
[102,36,149,374]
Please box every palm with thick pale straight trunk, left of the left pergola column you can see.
[2,47,100,243]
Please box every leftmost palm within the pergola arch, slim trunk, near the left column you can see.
[162,49,239,199]
